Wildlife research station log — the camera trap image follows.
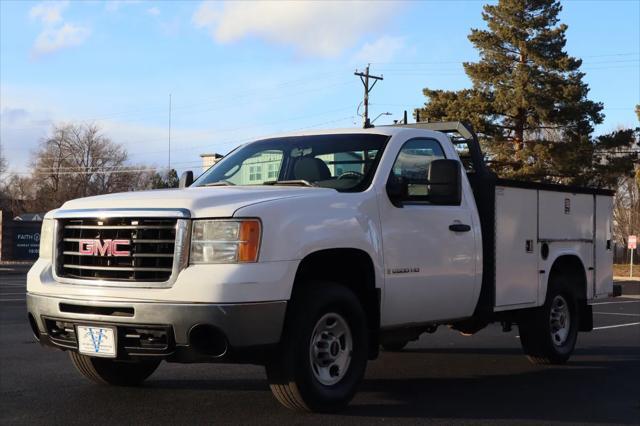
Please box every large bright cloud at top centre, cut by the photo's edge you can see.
[192,1,397,57]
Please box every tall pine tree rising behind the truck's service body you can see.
[418,0,634,185]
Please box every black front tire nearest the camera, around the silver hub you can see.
[266,282,368,412]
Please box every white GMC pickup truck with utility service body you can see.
[27,123,612,411]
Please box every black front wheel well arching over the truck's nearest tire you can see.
[291,248,380,359]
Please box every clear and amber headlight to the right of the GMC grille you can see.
[190,219,260,263]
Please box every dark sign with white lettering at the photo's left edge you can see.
[0,220,42,260]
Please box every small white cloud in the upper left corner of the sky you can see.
[29,1,91,56]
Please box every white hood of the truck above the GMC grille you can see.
[60,186,335,217]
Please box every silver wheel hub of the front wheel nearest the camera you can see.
[309,313,353,386]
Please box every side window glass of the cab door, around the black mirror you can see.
[391,139,446,201]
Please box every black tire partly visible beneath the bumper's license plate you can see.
[69,352,160,386]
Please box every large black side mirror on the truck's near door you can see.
[428,159,462,206]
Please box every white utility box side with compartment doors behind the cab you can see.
[495,186,613,311]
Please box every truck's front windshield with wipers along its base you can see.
[193,134,389,191]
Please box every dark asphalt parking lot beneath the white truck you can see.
[0,274,640,425]
